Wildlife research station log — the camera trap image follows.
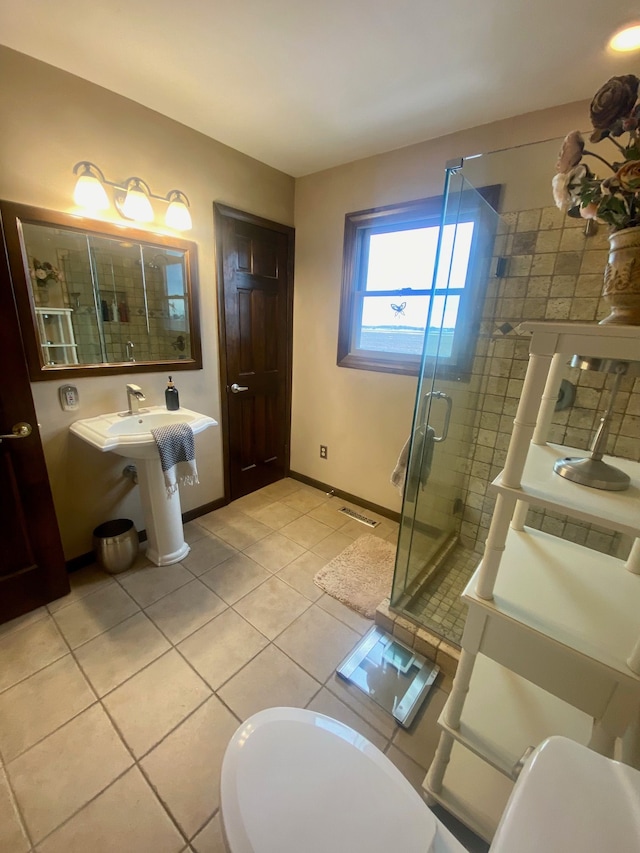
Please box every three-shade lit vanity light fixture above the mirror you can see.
[73,160,192,231]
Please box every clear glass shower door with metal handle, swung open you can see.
[391,161,499,612]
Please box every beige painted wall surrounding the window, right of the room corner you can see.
[291,103,588,510]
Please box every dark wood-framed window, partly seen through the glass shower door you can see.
[338,187,499,376]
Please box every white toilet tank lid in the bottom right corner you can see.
[491,736,640,853]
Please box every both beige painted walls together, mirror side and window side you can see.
[0,41,588,558]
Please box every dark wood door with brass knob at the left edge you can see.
[0,218,69,622]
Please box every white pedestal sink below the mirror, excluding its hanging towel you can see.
[69,406,217,566]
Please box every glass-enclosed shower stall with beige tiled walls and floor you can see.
[391,139,640,645]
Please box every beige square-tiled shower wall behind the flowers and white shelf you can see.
[461,207,640,556]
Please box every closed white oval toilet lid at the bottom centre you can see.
[220,708,437,853]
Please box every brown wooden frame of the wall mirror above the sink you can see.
[0,201,202,382]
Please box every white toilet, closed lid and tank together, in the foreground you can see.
[220,708,640,853]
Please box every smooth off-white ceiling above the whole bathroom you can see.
[0,0,640,177]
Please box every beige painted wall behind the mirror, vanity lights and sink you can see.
[0,47,294,559]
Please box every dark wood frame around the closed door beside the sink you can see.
[213,202,295,503]
